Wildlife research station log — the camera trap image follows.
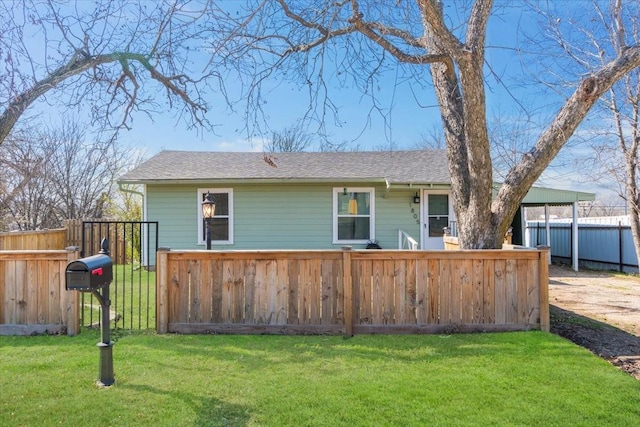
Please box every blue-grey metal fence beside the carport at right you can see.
[526,219,638,273]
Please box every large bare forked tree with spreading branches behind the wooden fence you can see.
[204,0,640,249]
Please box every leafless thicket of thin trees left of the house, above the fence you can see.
[0,119,131,230]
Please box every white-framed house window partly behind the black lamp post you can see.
[197,188,233,245]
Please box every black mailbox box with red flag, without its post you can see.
[65,254,113,291]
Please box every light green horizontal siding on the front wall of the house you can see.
[147,184,428,250]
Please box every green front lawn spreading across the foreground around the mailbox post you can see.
[0,331,640,426]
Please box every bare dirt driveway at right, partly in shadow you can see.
[549,265,640,380]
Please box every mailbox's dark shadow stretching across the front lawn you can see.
[118,384,250,427]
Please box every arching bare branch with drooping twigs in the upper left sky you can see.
[0,0,220,144]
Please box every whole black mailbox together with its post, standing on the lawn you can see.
[65,239,115,387]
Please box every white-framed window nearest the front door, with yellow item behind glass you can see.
[333,188,375,244]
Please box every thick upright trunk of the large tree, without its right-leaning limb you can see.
[421,1,506,249]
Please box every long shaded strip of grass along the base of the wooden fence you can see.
[123,331,566,369]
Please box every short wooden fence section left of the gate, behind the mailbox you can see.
[0,250,79,335]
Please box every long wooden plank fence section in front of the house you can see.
[156,249,549,336]
